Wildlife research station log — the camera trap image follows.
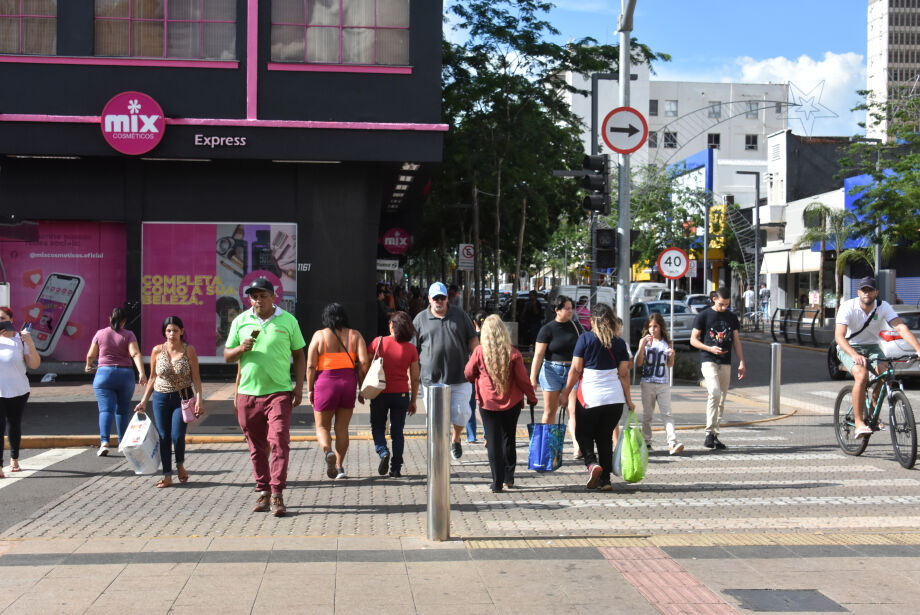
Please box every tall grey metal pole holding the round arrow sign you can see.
[616,0,636,347]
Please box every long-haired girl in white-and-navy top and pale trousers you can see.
[636,312,684,455]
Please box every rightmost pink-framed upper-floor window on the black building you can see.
[271,0,409,66]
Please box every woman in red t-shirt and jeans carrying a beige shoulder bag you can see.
[368,312,419,478]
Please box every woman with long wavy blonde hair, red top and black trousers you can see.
[464,314,537,493]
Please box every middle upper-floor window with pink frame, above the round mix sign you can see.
[94,0,237,60]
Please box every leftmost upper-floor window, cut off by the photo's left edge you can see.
[0,0,57,55]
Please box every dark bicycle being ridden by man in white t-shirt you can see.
[834,355,920,469]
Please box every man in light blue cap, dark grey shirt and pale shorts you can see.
[412,282,479,459]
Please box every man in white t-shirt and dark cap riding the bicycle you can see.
[834,276,920,437]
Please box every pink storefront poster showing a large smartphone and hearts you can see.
[0,220,126,361]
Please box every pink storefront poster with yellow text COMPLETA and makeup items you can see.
[141,222,297,362]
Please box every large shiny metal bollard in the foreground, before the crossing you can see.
[425,384,450,540]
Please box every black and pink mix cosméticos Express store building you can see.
[0,0,446,362]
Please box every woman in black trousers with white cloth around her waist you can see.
[561,303,635,491]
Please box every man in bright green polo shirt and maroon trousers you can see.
[224,278,306,517]
